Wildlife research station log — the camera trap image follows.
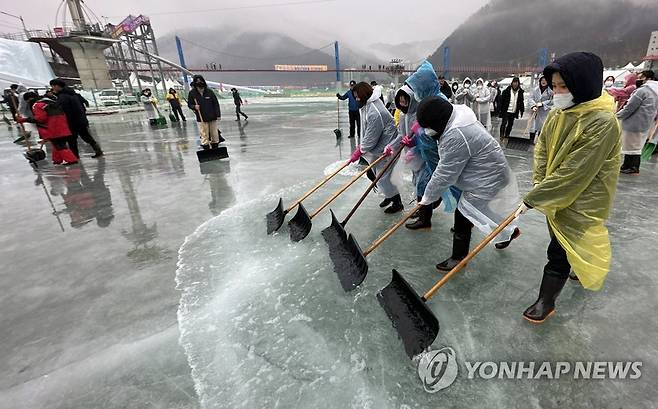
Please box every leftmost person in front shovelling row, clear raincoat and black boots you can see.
[350,82,404,214]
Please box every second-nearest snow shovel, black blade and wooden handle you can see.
[329,205,421,291]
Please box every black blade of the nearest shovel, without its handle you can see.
[377,269,439,358]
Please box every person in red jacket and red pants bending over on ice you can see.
[17,92,78,165]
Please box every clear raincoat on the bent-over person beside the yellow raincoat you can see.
[422,105,520,242]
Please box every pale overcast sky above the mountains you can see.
[0,0,488,48]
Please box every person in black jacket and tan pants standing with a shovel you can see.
[187,75,222,149]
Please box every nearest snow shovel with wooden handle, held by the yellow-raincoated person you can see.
[377,207,517,358]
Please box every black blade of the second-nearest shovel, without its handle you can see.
[329,234,368,292]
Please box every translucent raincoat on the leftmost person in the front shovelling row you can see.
[360,87,401,198]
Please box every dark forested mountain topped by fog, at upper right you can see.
[430,0,658,75]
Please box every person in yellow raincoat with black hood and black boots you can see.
[519,52,621,323]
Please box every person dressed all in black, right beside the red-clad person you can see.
[50,78,103,158]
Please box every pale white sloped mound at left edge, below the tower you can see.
[0,38,55,89]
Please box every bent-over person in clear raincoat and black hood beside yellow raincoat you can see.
[417,97,520,271]
